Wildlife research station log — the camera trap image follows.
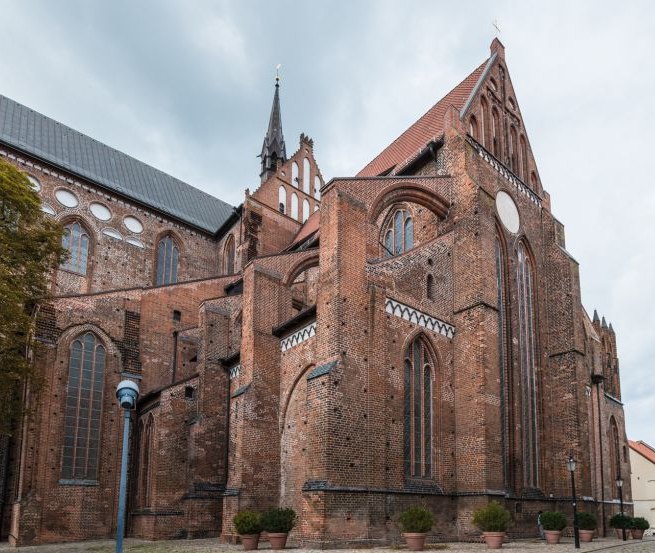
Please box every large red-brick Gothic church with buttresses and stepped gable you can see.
[0,39,630,546]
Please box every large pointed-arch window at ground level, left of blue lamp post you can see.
[61,332,106,480]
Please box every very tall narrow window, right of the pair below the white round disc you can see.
[517,242,539,488]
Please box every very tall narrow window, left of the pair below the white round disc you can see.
[495,237,510,486]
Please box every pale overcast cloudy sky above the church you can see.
[0,0,655,446]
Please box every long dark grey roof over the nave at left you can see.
[0,94,234,233]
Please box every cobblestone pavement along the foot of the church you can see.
[0,536,655,553]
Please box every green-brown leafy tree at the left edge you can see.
[0,160,66,434]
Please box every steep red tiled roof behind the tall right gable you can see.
[357,60,489,177]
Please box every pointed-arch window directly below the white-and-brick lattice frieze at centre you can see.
[404,336,435,478]
